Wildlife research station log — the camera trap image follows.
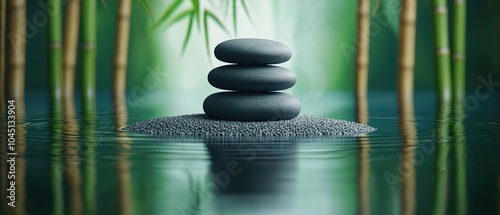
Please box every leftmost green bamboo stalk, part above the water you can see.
[47,0,62,109]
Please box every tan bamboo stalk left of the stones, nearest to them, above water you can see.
[113,0,131,99]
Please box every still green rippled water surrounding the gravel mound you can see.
[1,92,500,215]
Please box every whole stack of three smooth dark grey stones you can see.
[203,38,301,121]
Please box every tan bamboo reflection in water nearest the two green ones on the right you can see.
[399,95,417,215]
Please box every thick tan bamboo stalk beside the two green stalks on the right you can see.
[398,0,417,103]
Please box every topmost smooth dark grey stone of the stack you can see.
[214,38,292,64]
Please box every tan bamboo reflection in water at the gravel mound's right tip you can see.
[356,93,370,215]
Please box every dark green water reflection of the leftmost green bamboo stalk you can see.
[50,107,64,215]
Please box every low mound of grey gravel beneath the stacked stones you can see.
[123,114,376,137]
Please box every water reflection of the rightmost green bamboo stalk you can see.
[452,106,467,215]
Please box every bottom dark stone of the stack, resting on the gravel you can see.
[203,92,301,121]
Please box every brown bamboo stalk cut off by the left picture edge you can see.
[0,0,7,113]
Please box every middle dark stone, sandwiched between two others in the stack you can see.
[208,65,297,91]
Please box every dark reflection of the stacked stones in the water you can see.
[206,140,297,214]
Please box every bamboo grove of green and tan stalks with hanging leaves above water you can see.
[0,0,466,112]
